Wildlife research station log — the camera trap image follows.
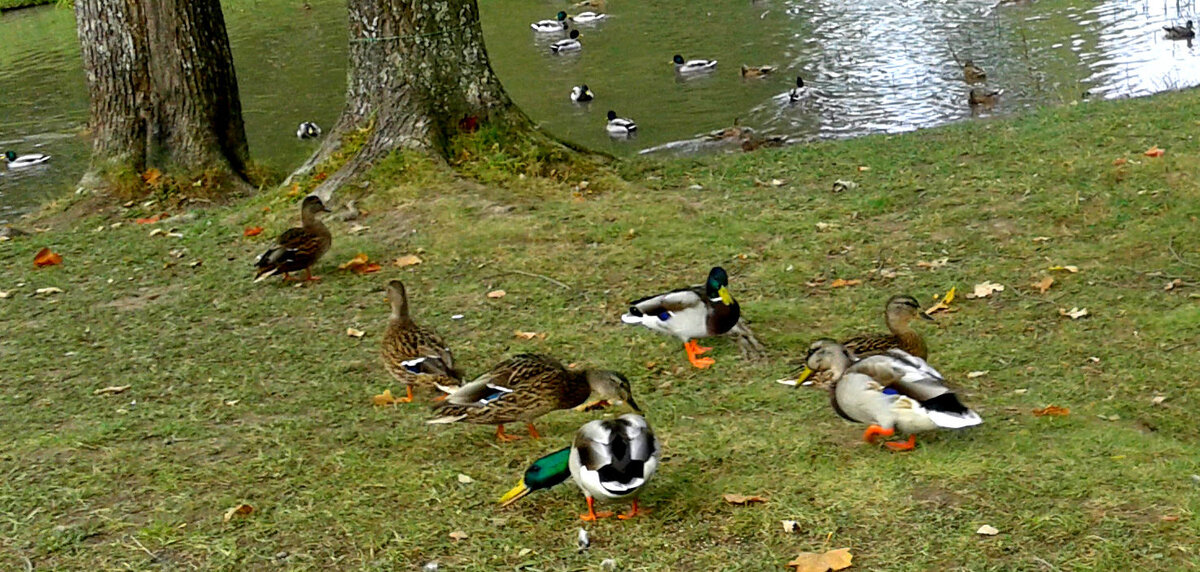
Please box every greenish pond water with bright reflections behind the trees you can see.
[0,0,1200,221]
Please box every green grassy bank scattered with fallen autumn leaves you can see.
[0,91,1200,571]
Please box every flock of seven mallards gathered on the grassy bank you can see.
[254,195,983,520]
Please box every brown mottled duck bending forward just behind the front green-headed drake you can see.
[428,354,641,441]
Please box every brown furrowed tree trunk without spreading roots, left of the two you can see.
[74,0,250,193]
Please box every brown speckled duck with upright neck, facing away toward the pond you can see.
[379,281,462,403]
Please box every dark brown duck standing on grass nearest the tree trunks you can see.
[254,194,334,282]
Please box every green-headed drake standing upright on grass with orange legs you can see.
[620,266,742,369]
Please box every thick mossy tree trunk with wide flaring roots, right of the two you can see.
[293,0,568,197]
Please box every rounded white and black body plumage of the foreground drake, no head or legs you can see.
[572,414,659,496]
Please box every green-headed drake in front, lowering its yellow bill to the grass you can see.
[500,414,660,520]
